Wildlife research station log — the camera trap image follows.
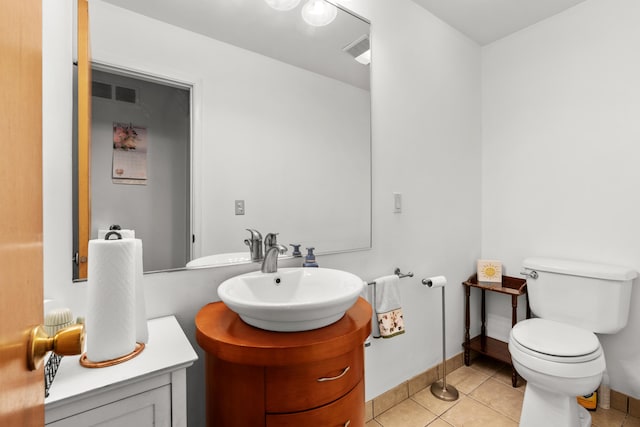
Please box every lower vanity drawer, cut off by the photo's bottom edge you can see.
[267,381,364,427]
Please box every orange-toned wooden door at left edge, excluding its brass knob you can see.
[0,0,44,426]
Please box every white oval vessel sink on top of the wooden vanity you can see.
[218,268,365,332]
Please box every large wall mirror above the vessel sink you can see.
[76,0,371,278]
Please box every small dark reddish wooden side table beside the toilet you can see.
[462,274,531,387]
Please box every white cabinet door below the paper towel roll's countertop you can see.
[47,385,171,427]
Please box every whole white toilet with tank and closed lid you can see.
[509,258,637,427]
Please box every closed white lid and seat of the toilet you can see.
[511,318,602,363]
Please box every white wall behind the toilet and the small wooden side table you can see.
[482,0,640,396]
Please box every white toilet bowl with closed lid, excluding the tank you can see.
[509,318,606,427]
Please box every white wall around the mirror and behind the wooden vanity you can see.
[44,0,480,425]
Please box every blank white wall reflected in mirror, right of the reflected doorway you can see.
[198,59,371,257]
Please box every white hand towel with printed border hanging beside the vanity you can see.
[375,274,404,338]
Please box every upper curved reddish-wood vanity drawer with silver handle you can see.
[265,346,364,414]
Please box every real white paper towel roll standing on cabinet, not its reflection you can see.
[86,239,136,362]
